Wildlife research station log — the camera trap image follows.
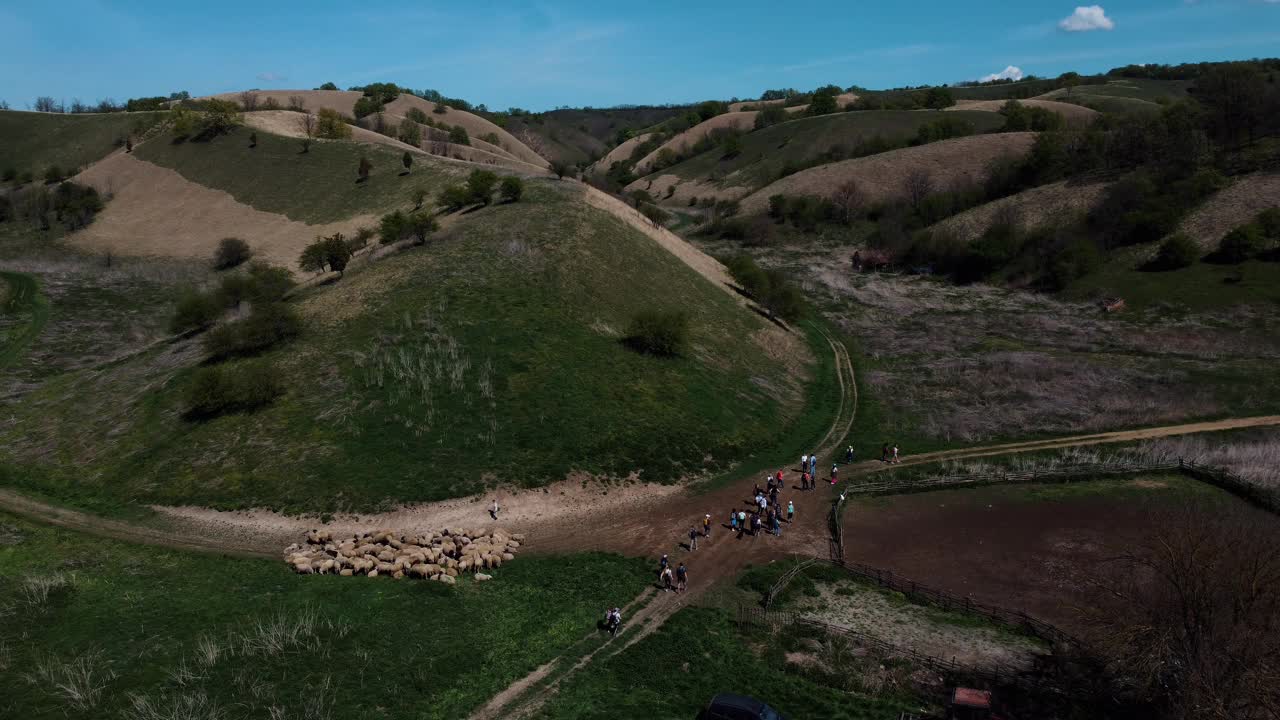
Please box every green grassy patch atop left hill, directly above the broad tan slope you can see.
[134,127,470,223]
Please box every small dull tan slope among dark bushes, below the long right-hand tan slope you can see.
[931,181,1111,242]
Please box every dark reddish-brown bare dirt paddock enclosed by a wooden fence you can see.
[844,479,1262,632]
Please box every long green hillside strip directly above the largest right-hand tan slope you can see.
[650,110,1004,190]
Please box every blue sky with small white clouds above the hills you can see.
[0,0,1280,110]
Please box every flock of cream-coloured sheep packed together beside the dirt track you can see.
[284,528,525,584]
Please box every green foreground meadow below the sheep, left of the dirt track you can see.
[0,515,650,720]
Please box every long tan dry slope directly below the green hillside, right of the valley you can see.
[742,132,1036,213]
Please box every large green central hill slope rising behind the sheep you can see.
[0,183,803,510]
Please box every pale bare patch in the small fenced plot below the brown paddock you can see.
[794,580,1047,670]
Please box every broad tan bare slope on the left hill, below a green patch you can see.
[69,152,376,269]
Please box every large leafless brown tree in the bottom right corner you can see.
[1083,503,1280,720]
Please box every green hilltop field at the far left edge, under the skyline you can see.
[0,110,164,178]
